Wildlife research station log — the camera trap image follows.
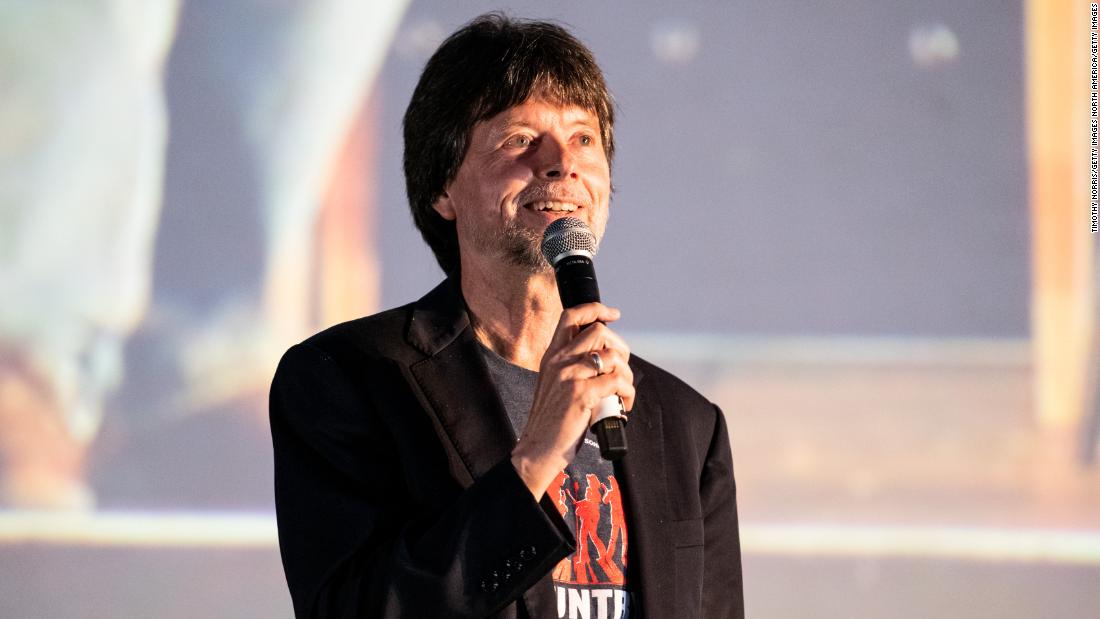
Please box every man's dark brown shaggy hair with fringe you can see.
[404,13,615,274]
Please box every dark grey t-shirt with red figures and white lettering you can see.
[482,346,636,619]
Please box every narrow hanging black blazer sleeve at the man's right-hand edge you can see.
[700,405,745,619]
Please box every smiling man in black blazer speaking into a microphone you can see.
[271,15,744,618]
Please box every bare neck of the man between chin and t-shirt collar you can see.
[462,261,561,372]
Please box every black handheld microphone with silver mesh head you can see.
[542,217,626,460]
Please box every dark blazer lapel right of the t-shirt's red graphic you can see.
[615,367,677,617]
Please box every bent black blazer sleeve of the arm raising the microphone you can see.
[270,343,573,618]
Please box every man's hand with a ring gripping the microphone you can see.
[512,303,634,500]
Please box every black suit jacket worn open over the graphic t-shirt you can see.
[271,278,744,619]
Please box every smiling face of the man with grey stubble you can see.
[433,99,611,273]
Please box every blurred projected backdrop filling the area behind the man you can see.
[0,0,1100,618]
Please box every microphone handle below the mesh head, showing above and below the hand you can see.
[554,254,626,461]
